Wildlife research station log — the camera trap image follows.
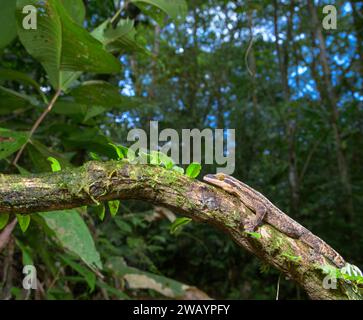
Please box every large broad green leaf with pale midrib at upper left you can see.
[16,0,120,90]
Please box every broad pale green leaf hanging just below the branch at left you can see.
[39,210,102,269]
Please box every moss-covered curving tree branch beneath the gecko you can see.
[0,161,360,299]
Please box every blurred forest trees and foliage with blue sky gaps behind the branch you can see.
[0,0,363,299]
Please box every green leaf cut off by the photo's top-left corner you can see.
[0,0,16,49]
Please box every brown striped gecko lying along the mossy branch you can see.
[203,173,346,268]
